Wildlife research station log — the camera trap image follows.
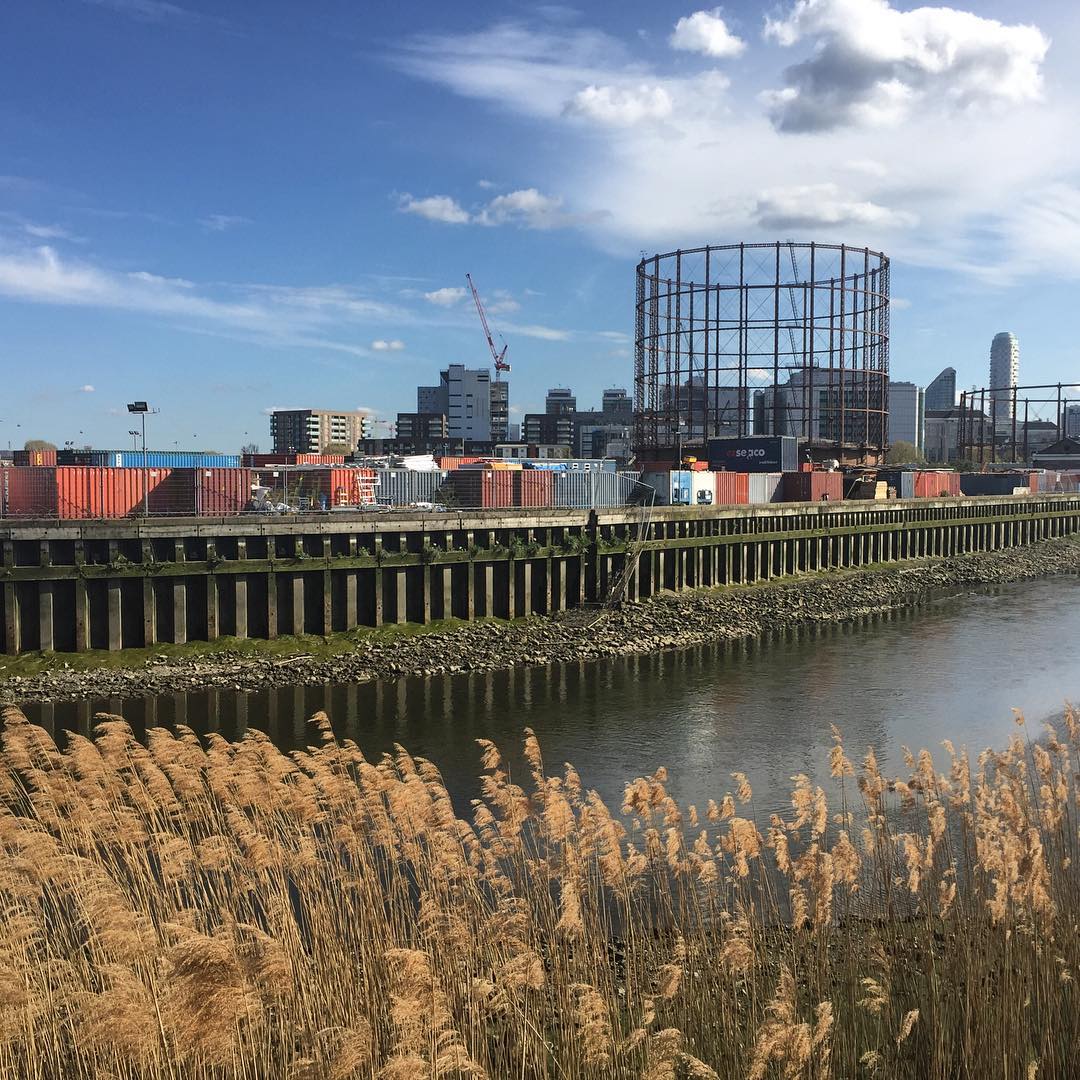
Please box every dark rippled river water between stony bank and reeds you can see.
[16,577,1080,820]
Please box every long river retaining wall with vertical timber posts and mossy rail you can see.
[0,494,1080,654]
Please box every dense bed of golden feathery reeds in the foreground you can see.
[0,710,1080,1080]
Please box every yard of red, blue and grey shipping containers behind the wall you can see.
[0,449,1080,521]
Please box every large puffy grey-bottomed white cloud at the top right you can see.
[765,0,1050,132]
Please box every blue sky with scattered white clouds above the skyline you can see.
[0,0,1080,450]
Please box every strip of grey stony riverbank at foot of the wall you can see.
[0,539,1080,703]
